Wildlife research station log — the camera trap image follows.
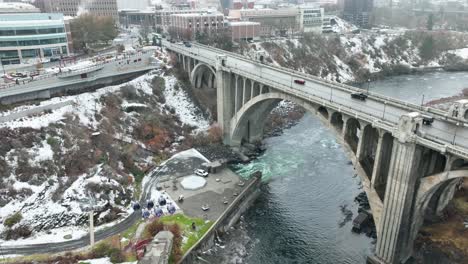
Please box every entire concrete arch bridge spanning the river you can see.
[162,40,468,264]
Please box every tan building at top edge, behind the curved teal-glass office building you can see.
[35,0,119,22]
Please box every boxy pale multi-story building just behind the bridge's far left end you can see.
[169,12,226,39]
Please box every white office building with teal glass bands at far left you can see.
[0,13,70,64]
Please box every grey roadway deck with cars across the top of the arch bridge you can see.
[162,40,468,158]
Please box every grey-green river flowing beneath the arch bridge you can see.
[209,72,468,264]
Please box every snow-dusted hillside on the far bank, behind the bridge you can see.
[240,30,468,82]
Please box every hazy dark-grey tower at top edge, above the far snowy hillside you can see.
[343,0,373,28]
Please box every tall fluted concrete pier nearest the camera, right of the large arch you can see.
[375,113,422,264]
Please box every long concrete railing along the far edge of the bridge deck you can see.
[166,40,460,122]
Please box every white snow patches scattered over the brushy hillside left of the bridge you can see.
[0,52,209,245]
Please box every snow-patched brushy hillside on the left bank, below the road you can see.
[0,54,209,245]
